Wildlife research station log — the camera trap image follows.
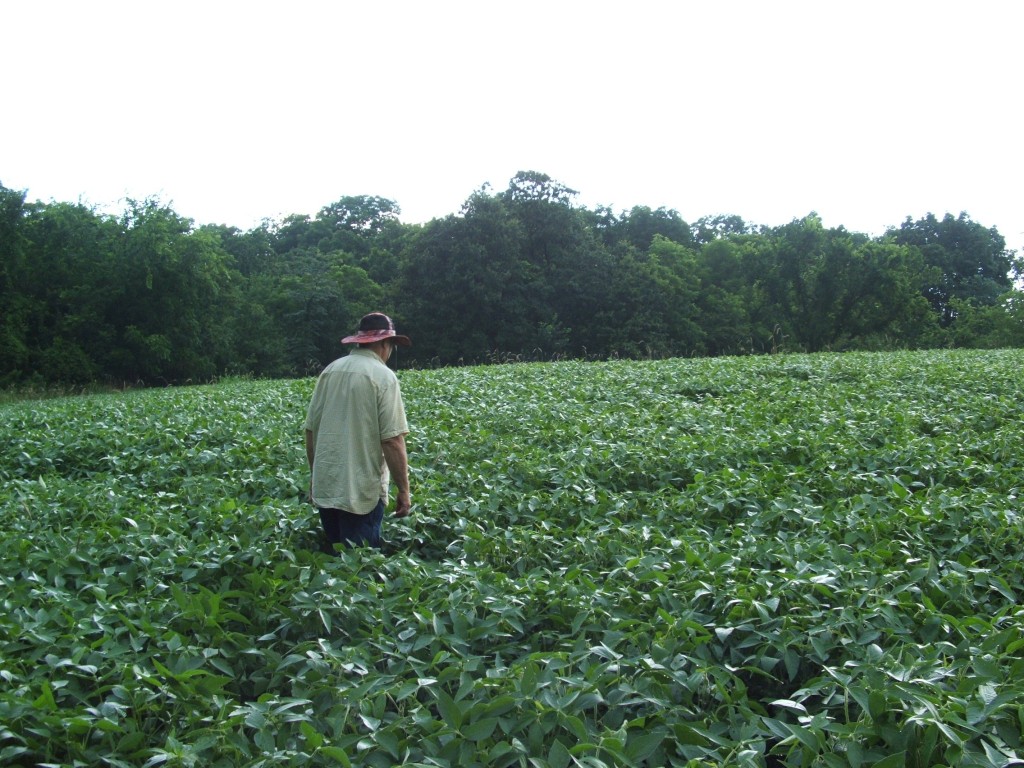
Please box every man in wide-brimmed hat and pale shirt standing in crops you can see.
[305,312,412,547]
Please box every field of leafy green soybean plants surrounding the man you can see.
[0,350,1024,768]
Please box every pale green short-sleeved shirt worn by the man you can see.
[305,349,409,515]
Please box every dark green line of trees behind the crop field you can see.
[0,176,1024,386]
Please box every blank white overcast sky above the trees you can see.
[0,0,1024,256]
